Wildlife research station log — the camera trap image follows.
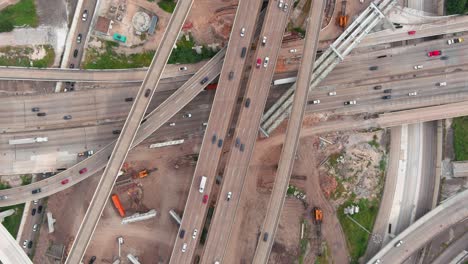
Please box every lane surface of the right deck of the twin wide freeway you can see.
[202,0,287,262]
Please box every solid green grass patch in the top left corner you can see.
[0,0,38,32]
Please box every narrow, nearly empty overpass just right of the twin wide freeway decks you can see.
[253,0,326,263]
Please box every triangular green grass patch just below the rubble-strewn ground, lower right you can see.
[337,199,379,263]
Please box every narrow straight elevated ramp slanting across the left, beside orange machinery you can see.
[65,0,193,264]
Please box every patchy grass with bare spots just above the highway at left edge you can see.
[0,45,55,68]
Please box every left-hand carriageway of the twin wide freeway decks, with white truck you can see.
[170,0,262,263]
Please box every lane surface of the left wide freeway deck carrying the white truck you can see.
[170,1,266,263]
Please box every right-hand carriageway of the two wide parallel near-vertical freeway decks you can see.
[201,1,292,263]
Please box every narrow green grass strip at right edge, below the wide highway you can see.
[452,116,468,161]
